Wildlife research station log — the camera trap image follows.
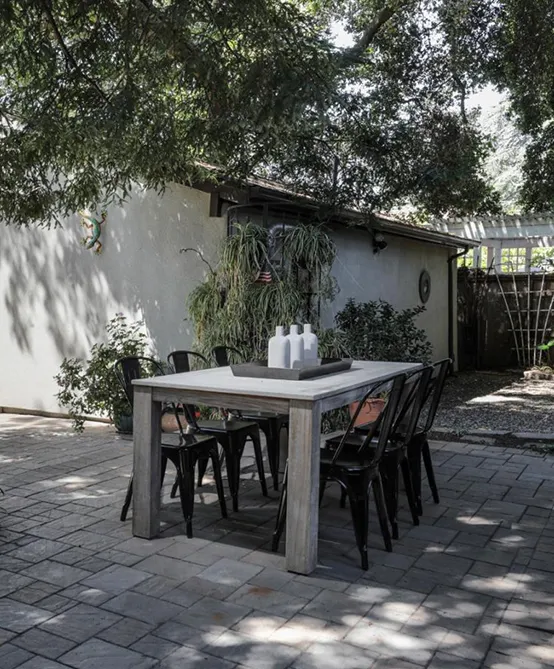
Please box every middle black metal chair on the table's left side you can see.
[167,350,267,511]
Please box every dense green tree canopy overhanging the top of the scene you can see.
[0,0,554,224]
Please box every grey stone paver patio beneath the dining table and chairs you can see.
[0,414,554,669]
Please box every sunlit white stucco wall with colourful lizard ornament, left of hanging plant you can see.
[0,185,226,411]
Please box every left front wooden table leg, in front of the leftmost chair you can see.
[133,386,162,539]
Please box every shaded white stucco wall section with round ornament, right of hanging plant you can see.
[322,228,455,359]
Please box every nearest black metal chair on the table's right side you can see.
[272,374,406,570]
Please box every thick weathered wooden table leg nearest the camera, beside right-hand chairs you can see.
[286,400,321,574]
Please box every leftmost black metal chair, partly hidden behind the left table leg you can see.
[114,356,227,538]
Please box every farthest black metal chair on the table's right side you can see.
[408,358,452,516]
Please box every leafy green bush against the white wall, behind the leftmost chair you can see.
[54,314,147,432]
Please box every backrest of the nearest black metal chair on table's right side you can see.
[332,374,406,466]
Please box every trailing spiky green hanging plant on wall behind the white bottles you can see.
[188,222,336,360]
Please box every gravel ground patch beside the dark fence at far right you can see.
[434,372,554,434]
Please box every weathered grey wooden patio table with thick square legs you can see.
[133,361,420,574]
